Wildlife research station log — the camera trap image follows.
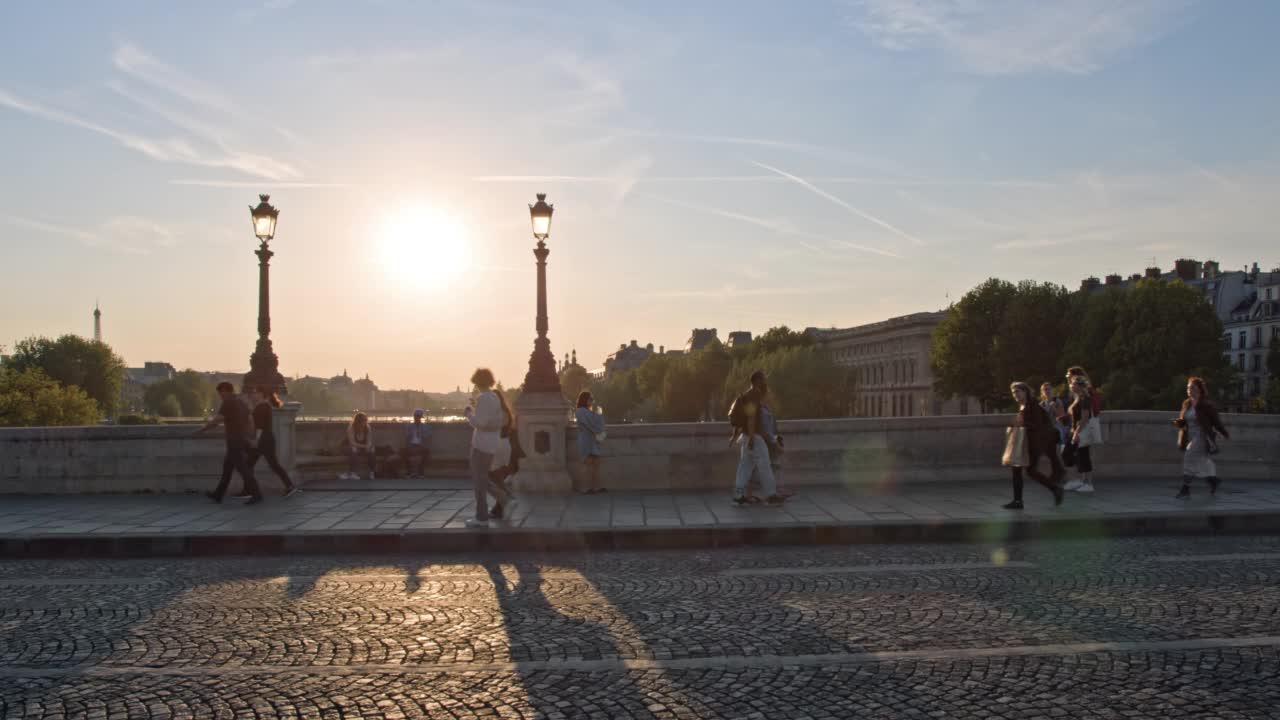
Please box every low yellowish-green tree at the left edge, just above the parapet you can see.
[0,366,102,427]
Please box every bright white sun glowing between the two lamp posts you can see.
[378,205,471,290]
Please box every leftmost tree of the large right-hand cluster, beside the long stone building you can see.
[929,278,1018,410]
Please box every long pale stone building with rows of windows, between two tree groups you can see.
[805,313,978,418]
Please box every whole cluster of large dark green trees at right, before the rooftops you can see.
[932,274,1249,411]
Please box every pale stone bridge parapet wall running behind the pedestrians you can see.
[0,409,1280,493]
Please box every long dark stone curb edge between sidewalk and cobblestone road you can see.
[0,504,1280,559]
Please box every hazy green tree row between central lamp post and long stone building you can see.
[561,325,854,423]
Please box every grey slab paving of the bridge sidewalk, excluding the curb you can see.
[0,480,1280,539]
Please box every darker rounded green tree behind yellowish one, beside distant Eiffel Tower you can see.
[8,334,124,418]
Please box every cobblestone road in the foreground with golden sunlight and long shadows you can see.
[0,538,1280,719]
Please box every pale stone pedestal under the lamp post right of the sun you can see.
[511,392,573,495]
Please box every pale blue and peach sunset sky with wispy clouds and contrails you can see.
[0,0,1280,391]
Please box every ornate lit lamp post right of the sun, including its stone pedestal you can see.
[512,192,573,493]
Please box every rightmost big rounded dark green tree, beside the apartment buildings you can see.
[1103,279,1234,410]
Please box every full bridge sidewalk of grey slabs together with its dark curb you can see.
[0,479,1280,556]
